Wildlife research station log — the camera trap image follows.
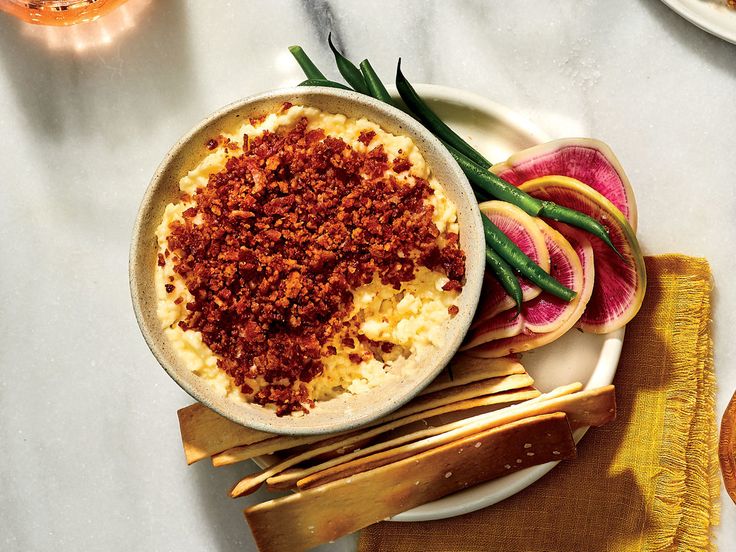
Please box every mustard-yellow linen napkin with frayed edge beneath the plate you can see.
[358,255,720,552]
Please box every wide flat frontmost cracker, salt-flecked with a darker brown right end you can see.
[244,413,575,552]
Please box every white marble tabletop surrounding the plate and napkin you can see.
[0,0,736,552]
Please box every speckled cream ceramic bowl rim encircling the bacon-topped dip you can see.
[129,87,485,435]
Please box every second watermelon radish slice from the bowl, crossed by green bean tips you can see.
[461,219,585,354]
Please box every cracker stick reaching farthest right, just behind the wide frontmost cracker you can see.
[297,385,616,489]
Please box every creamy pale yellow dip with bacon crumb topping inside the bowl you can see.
[156,104,465,415]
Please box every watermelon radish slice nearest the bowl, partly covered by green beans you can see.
[475,201,549,324]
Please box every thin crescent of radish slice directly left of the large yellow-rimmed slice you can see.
[465,223,595,358]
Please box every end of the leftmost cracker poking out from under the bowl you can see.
[177,403,274,464]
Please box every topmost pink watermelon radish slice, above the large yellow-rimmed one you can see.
[491,138,637,231]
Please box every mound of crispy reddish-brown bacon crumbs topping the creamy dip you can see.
[167,119,465,415]
